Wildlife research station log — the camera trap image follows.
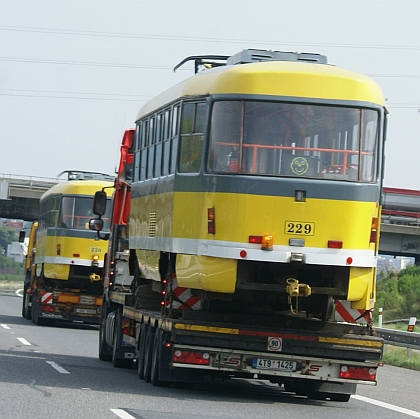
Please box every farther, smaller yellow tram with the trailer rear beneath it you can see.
[30,171,114,324]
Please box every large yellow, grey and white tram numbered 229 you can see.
[129,50,387,319]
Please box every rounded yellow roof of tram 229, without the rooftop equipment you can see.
[136,61,385,120]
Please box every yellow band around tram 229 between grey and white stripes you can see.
[130,192,378,250]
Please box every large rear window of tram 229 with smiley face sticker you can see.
[207,101,379,182]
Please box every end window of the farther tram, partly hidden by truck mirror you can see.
[59,196,111,231]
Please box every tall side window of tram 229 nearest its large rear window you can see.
[178,102,206,173]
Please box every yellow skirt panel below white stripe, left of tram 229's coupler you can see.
[176,254,238,294]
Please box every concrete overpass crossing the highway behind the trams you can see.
[0,174,420,265]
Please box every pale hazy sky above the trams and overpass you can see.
[0,0,420,190]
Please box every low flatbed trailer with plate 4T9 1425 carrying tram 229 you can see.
[100,291,383,401]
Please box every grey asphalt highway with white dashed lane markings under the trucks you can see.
[0,292,420,419]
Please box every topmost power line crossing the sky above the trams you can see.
[0,25,420,51]
